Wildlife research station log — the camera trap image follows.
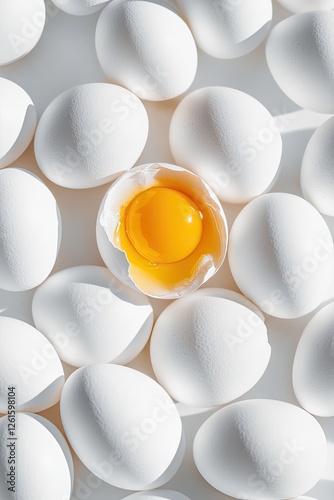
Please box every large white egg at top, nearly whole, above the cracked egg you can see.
[95,0,197,101]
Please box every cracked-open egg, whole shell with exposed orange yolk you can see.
[96,163,228,299]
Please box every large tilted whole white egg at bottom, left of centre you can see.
[60,364,184,490]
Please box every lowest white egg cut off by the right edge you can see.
[293,302,334,417]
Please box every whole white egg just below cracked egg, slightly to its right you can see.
[151,288,271,407]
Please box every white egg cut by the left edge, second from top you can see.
[0,78,37,168]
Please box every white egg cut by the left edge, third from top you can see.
[0,168,61,292]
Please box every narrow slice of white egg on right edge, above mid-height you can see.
[300,118,334,217]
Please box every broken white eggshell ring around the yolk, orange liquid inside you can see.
[96,163,227,299]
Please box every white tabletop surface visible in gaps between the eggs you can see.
[0,1,334,500]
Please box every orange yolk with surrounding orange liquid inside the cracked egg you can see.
[114,178,225,295]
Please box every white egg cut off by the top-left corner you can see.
[0,0,46,66]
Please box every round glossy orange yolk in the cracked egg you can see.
[125,187,202,264]
